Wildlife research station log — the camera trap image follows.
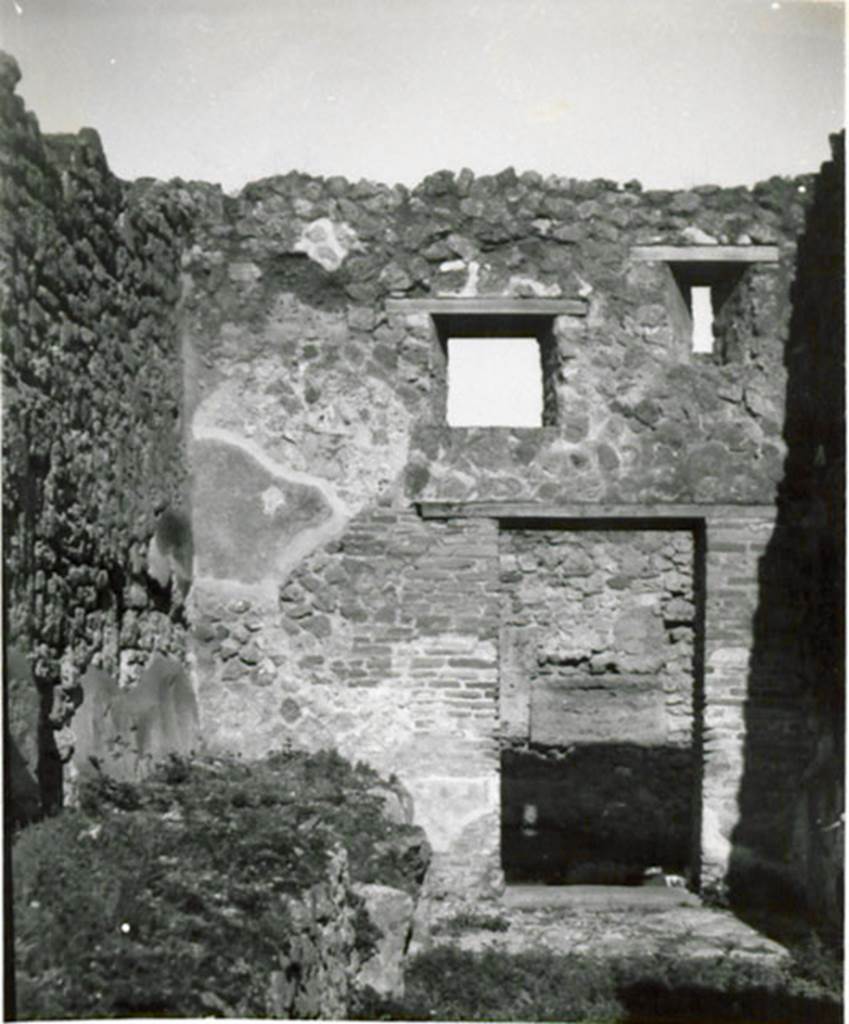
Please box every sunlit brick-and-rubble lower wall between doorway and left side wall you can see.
[195,509,499,890]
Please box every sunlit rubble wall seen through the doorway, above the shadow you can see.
[500,528,695,745]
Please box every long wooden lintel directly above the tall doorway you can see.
[416,501,776,519]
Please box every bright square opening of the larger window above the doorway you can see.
[447,338,543,427]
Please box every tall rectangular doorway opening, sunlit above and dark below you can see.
[499,520,704,887]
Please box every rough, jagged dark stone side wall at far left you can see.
[0,57,193,818]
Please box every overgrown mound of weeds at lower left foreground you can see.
[12,753,426,1019]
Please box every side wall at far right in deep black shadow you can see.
[728,136,845,926]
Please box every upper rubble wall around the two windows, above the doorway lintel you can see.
[184,171,810,521]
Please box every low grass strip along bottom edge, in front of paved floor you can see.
[354,946,842,1024]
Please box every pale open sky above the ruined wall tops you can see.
[0,0,844,190]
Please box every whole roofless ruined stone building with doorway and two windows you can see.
[3,51,843,925]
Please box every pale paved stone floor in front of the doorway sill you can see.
[421,886,788,963]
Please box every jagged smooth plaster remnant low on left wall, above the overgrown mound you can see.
[73,654,199,781]
